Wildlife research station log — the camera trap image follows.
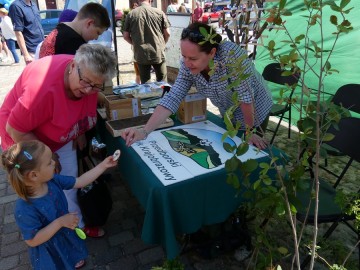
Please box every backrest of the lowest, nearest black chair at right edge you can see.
[326,117,360,162]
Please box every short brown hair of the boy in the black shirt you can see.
[76,3,110,29]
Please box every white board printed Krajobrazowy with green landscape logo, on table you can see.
[132,121,268,186]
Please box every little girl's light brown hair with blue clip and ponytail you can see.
[1,141,45,201]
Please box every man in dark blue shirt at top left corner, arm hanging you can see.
[9,0,44,64]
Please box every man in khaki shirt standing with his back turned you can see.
[123,0,170,83]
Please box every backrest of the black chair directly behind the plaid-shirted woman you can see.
[262,63,300,86]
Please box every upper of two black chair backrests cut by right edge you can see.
[332,84,360,113]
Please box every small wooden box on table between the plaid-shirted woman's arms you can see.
[177,93,206,124]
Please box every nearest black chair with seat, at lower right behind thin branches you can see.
[296,117,360,269]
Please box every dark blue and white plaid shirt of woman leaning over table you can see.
[160,41,273,127]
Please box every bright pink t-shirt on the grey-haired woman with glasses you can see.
[0,55,97,151]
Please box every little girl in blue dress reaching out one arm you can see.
[1,141,117,270]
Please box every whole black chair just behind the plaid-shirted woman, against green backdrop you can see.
[262,63,300,144]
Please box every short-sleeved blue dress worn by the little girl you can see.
[15,175,88,270]
